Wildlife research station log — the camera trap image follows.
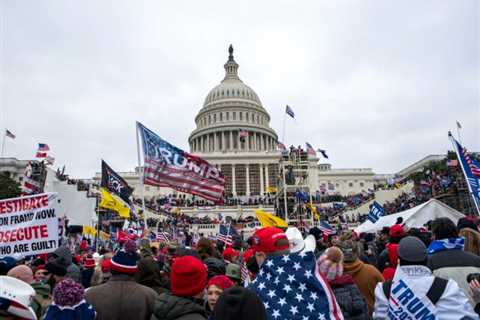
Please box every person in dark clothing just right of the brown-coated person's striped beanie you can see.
[135,239,166,294]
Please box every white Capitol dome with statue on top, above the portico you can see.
[188,46,277,153]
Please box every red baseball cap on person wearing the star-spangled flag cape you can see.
[252,227,290,253]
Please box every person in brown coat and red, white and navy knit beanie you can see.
[86,240,157,320]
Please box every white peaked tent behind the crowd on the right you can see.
[355,199,465,233]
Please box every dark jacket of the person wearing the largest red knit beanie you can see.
[151,293,206,320]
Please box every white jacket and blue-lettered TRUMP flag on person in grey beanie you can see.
[373,265,478,320]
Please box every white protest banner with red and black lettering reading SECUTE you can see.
[0,193,60,258]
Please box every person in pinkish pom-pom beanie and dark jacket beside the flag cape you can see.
[317,247,369,320]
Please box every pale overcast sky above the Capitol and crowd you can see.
[0,0,480,178]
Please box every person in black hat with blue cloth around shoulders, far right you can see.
[428,218,480,305]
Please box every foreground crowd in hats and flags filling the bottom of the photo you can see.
[0,217,480,320]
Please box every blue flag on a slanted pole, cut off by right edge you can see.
[449,133,480,214]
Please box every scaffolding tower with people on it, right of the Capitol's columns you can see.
[276,149,314,227]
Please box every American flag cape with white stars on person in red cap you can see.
[248,252,343,320]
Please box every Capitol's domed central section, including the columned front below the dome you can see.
[188,46,280,196]
